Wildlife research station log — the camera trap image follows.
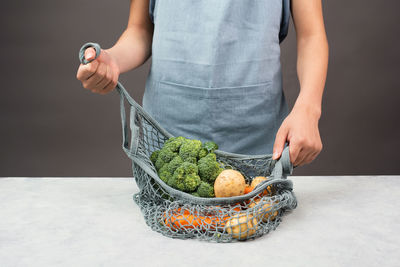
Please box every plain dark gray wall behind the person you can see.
[0,0,400,176]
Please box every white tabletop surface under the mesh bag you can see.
[0,176,400,267]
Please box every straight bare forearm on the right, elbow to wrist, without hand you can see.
[294,33,329,118]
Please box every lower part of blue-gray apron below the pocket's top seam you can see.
[143,81,281,154]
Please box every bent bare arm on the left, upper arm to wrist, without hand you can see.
[106,0,153,73]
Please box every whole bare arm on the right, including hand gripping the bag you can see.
[273,0,329,166]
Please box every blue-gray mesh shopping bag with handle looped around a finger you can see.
[79,43,297,242]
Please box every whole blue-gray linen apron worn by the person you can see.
[143,0,289,155]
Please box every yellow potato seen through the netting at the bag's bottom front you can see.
[225,213,257,240]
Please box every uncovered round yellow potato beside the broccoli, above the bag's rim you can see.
[214,170,246,197]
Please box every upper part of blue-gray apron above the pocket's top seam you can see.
[148,0,282,88]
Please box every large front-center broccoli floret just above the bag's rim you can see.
[168,162,201,192]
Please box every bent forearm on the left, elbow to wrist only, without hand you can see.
[105,25,153,73]
